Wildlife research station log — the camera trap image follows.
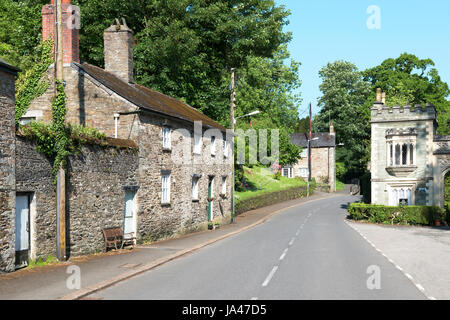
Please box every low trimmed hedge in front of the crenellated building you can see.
[348,203,445,225]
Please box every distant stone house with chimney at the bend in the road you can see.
[282,124,336,192]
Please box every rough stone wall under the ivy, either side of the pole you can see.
[16,137,138,259]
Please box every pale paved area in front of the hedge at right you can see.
[349,222,450,300]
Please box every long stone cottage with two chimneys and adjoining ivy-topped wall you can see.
[2,1,232,270]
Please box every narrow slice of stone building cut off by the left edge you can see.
[0,60,18,273]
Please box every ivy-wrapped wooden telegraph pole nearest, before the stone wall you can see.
[54,0,66,261]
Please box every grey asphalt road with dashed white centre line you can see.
[89,195,426,300]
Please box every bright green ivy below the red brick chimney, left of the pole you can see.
[15,40,53,123]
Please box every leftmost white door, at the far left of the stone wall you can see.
[16,196,30,251]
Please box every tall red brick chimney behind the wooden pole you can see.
[42,0,80,63]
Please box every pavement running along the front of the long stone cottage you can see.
[0,192,339,300]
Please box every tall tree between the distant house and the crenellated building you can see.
[314,61,370,176]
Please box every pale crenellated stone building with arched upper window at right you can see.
[370,89,450,207]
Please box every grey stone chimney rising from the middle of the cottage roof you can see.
[104,18,133,83]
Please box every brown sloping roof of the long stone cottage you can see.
[73,62,226,131]
